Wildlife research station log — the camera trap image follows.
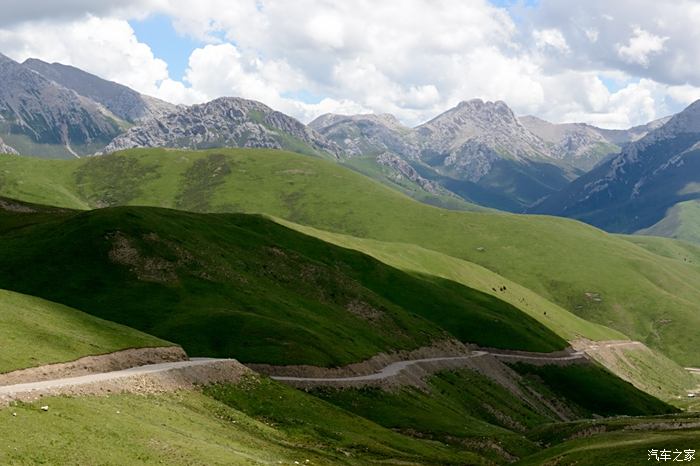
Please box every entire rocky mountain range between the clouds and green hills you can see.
[0,55,700,244]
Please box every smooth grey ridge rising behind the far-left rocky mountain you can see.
[23,58,175,123]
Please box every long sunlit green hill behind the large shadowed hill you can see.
[0,150,700,364]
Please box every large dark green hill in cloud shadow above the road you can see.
[0,207,566,366]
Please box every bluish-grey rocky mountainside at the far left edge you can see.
[0,55,121,152]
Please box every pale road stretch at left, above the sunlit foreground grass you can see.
[0,358,227,396]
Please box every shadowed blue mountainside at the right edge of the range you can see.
[536,101,700,232]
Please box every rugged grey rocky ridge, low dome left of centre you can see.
[103,97,340,157]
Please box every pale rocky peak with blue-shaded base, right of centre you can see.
[310,99,574,211]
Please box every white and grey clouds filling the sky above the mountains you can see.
[0,0,700,127]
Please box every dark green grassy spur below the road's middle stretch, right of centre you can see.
[312,369,552,462]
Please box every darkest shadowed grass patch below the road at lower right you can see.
[512,363,677,416]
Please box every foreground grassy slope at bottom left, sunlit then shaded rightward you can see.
[0,380,483,465]
